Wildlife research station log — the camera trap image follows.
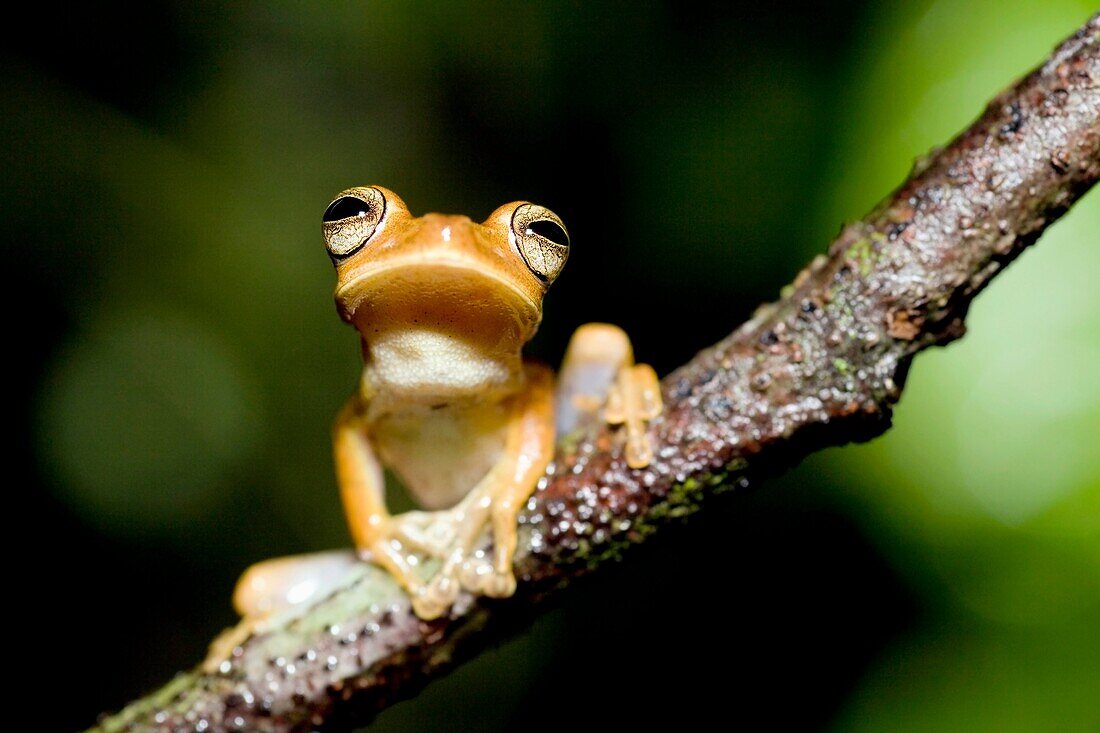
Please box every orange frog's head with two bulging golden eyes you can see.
[322,186,569,396]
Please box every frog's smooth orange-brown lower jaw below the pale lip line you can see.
[336,259,541,342]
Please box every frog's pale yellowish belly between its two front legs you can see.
[371,404,508,510]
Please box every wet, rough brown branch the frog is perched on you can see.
[98,14,1100,731]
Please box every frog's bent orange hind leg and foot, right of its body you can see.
[557,324,662,468]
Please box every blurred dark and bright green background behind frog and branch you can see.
[0,0,1100,731]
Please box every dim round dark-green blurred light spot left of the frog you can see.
[40,309,264,539]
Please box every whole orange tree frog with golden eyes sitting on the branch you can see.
[234,186,661,619]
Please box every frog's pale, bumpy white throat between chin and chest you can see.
[362,328,524,412]
